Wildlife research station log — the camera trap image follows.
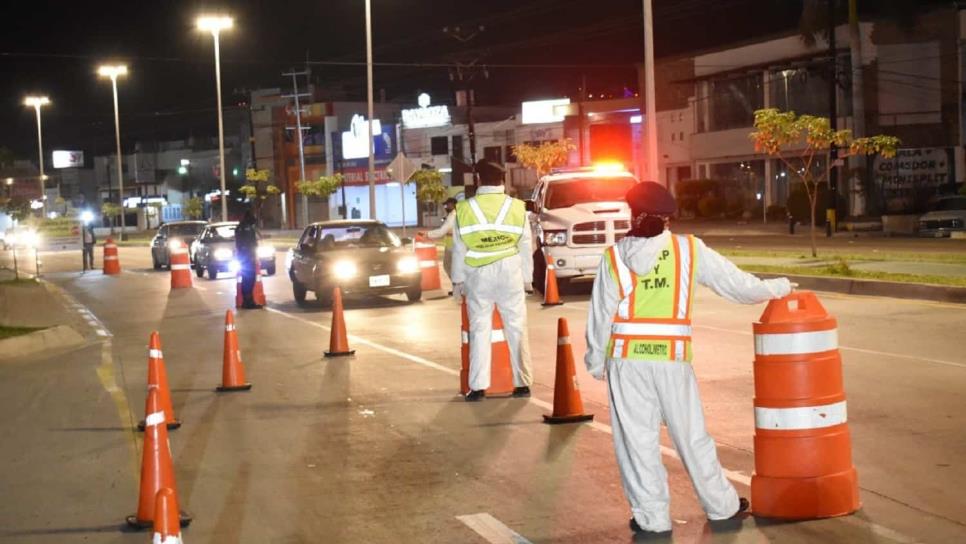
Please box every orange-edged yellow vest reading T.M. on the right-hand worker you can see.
[604,235,697,363]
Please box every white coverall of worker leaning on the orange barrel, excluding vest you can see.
[584,230,791,532]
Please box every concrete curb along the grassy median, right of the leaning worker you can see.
[754,272,966,304]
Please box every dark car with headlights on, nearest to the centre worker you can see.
[288,220,423,305]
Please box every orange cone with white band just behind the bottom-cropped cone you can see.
[126,387,191,529]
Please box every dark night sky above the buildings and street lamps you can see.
[0,0,801,159]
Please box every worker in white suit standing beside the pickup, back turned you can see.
[452,161,533,401]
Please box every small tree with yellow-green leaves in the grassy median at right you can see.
[749,108,899,257]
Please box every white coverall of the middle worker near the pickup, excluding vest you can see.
[451,185,533,391]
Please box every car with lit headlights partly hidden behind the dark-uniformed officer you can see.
[188,221,275,280]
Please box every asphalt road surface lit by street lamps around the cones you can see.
[0,248,966,544]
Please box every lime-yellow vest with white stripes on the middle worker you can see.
[456,193,527,268]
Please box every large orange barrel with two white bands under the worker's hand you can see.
[751,291,861,519]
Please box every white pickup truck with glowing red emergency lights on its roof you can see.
[527,166,637,292]
